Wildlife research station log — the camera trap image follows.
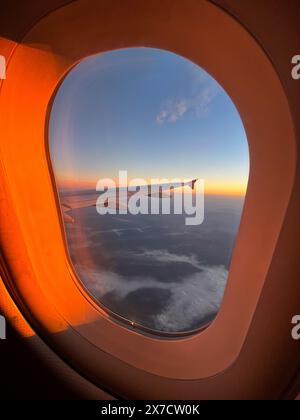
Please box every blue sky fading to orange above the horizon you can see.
[49,48,249,195]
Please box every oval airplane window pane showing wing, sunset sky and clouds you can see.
[49,48,249,334]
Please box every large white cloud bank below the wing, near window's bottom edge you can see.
[76,251,228,331]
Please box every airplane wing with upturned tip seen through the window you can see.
[60,179,197,223]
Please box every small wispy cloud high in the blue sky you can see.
[156,84,219,124]
